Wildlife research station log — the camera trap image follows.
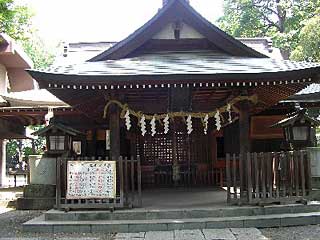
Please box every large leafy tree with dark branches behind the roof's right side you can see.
[219,0,320,59]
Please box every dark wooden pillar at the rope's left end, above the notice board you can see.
[109,106,120,160]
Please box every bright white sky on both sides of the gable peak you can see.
[20,0,223,42]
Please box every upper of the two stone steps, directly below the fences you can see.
[44,204,320,221]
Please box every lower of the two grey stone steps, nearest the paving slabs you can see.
[23,212,320,233]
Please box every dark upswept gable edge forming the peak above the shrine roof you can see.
[89,0,267,62]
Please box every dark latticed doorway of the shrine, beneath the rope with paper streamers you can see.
[130,118,225,189]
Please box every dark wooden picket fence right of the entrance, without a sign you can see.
[226,151,311,204]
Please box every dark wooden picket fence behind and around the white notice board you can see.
[56,157,142,209]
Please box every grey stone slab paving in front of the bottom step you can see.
[114,228,268,240]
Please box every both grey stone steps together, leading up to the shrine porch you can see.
[23,204,320,233]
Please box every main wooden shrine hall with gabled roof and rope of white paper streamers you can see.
[28,0,320,206]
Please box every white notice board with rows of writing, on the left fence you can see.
[66,161,116,199]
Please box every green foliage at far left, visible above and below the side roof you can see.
[0,0,54,168]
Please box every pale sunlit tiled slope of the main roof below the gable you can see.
[46,51,320,76]
